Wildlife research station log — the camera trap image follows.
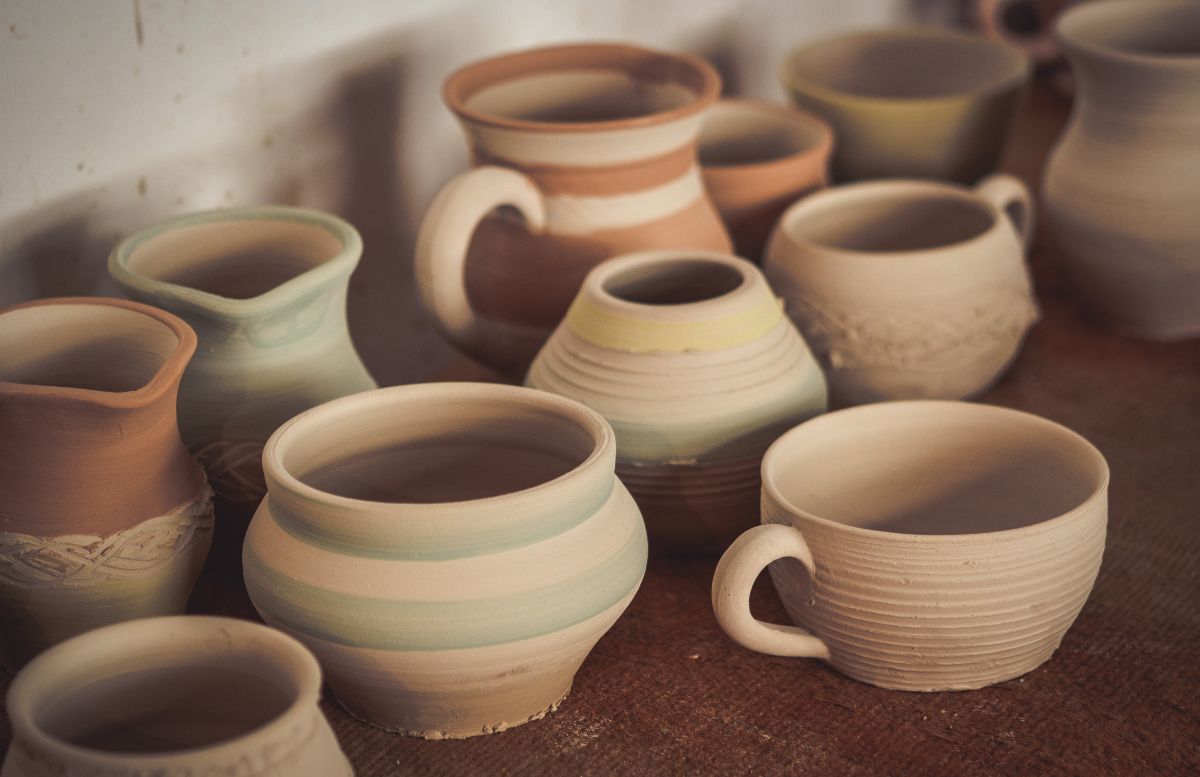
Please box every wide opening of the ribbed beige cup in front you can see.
[767,402,1108,535]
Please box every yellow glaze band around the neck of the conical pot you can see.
[566,295,784,354]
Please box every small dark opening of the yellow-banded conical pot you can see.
[601,258,746,306]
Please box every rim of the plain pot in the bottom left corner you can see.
[6,615,322,771]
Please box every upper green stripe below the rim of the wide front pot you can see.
[268,476,617,561]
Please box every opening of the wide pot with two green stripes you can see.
[277,393,601,504]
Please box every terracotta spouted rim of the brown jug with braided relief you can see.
[0,296,197,410]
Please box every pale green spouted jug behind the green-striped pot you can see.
[108,207,374,501]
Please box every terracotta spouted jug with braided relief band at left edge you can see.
[0,297,212,668]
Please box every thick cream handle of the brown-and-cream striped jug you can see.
[414,165,546,366]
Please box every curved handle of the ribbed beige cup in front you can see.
[713,524,829,661]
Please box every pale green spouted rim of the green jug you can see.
[108,205,362,319]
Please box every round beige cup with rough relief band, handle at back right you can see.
[763,174,1038,405]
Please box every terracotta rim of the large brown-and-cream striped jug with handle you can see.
[442,42,721,134]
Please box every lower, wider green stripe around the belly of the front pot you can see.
[244,526,647,650]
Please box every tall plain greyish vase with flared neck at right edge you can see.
[1043,0,1200,341]
